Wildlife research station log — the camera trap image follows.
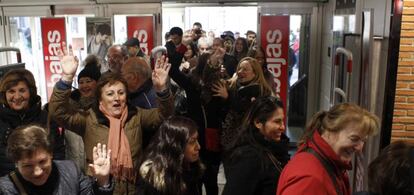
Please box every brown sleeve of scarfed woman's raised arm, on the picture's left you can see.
[49,81,86,136]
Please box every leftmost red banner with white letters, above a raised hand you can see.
[40,18,66,100]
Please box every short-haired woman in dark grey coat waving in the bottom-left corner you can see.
[0,125,113,195]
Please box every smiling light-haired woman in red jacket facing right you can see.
[277,103,379,195]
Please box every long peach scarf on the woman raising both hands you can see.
[99,105,135,182]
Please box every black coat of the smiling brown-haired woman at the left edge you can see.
[0,96,64,176]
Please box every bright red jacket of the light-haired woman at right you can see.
[277,131,351,195]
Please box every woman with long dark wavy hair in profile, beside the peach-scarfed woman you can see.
[137,117,202,195]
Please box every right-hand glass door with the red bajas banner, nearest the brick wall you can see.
[258,3,319,147]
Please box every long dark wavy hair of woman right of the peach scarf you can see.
[140,116,201,195]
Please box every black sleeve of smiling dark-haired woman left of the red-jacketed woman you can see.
[223,151,260,195]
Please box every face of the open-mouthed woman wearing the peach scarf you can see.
[99,81,127,118]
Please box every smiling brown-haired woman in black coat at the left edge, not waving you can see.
[0,69,64,176]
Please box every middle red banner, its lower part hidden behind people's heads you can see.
[127,16,154,55]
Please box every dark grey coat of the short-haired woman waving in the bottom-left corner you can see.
[0,160,114,195]
